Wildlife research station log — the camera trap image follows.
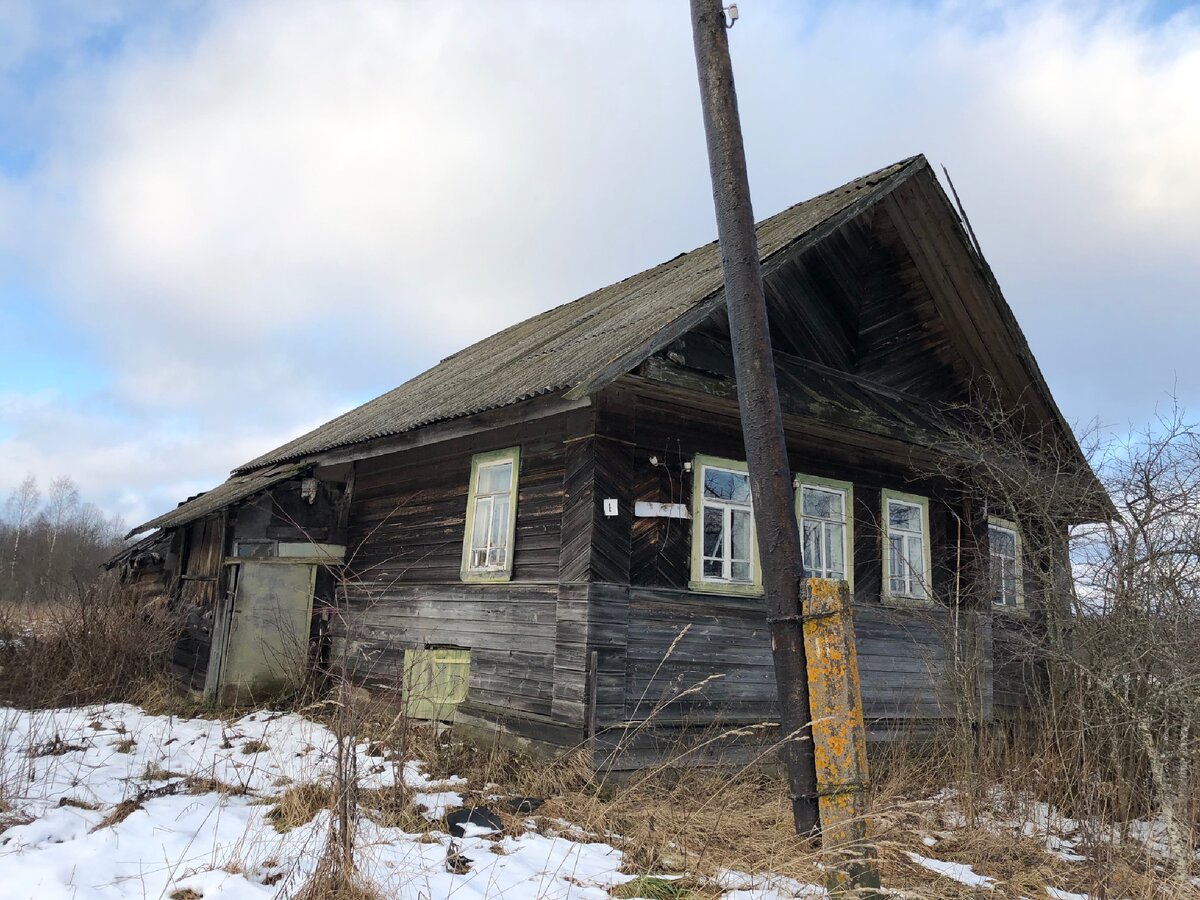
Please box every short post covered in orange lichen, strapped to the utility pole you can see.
[800,578,877,887]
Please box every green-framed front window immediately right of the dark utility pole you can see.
[796,475,854,587]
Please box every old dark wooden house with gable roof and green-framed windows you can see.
[113,156,1086,767]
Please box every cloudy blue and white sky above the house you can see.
[0,0,1200,524]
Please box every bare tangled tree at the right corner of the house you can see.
[931,397,1200,883]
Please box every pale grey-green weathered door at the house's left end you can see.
[220,560,317,703]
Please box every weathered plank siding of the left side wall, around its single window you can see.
[332,409,592,721]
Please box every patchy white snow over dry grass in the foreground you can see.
[0,704,1150,900]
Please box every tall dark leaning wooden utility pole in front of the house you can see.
[691,0,818,836]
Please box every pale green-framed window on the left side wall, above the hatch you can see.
[462,446,521,581]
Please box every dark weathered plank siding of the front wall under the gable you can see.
[578,378,992,767]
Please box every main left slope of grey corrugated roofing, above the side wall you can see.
[235,156,928,473]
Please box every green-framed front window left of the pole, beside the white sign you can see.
[691,456,761,593]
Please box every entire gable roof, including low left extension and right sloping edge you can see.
[130,156,1084,535]
